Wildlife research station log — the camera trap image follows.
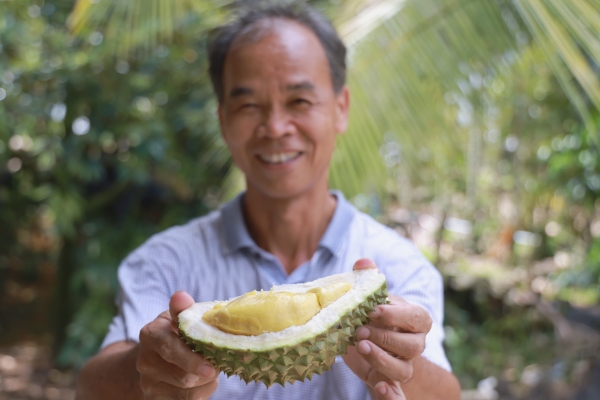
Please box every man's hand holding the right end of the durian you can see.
[344,259,432,400]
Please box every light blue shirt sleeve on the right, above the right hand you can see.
[374,232,452,371]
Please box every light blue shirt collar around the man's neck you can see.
[221,190,355,254]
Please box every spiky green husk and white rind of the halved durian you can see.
[178,269,387,387]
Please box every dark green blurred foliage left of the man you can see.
[0,1,229,365]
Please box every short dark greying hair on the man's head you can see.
[207,1,346,103]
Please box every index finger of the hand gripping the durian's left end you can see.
[140,318,216,378]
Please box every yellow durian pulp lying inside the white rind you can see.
[202,282,352,336]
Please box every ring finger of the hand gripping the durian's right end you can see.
[356,340,413,386]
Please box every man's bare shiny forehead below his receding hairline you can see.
[223,19,331,92]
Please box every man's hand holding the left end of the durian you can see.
[137,292,219,400]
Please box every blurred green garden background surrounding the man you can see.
[0,0,600,400]
